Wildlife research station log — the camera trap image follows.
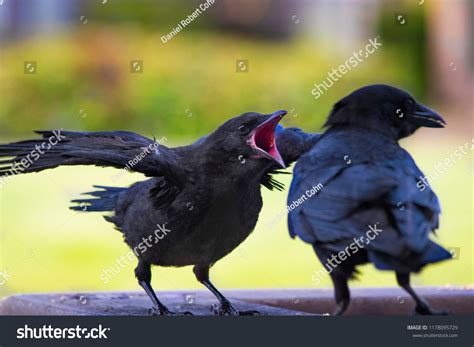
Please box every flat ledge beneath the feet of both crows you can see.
[0,286,474,316]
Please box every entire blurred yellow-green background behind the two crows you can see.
[0,0,473,295]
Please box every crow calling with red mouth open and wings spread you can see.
[0,111,286,315]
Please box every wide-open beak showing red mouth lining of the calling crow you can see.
[249,110,287,168]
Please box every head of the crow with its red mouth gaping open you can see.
[203,110,286,169]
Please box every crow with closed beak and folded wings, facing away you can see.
[286,85,451,314]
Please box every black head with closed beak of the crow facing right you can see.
[325,84,446,140]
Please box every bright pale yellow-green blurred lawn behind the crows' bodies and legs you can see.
[0,136,473,295]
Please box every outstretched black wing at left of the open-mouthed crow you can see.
[0,130,180,177]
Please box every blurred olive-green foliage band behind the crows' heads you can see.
[0,24,418,137]
